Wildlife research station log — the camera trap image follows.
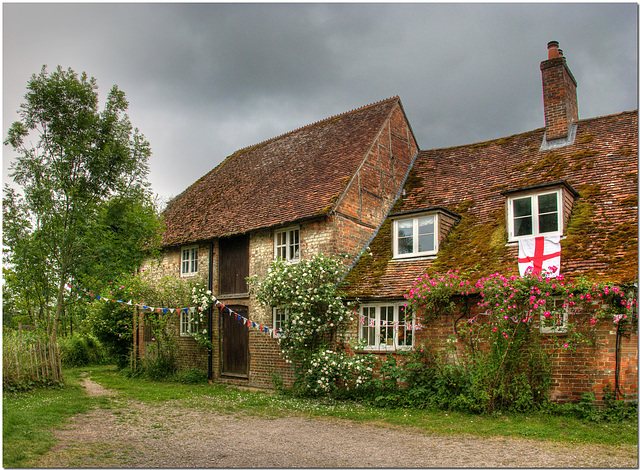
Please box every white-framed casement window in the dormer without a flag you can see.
[393,214,438,258]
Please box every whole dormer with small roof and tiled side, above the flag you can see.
[503,183,578,241]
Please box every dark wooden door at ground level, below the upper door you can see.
[220,305,249,377]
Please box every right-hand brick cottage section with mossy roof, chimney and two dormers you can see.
[345,42,638,401]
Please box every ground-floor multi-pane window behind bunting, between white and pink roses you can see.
[358,303,415,351]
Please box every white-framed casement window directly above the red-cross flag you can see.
[507,190,563,241]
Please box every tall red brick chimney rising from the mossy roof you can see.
[540,41,578,147]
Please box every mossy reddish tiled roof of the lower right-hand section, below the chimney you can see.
[345,111,638,298]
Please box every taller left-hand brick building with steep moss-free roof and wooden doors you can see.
[139,97,418,387]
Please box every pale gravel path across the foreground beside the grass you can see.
[37,378,638,468]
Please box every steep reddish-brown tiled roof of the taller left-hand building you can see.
[162,97,400,246]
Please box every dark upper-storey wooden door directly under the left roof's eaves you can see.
[219,235,249,294]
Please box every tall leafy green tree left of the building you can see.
[3,66,158,340]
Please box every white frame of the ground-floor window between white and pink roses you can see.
[358,302,416,351]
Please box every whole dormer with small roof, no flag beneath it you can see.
[392,207,460,259]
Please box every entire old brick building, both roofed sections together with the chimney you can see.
[140,42,638,401]
